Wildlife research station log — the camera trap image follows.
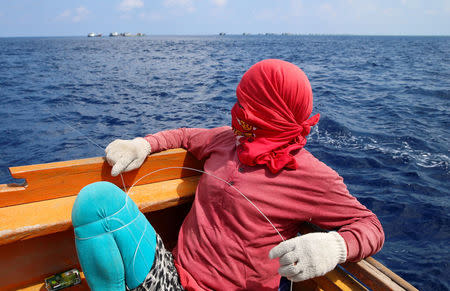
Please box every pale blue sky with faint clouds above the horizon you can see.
[0,0,450,37]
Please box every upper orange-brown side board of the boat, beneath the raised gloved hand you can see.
[0,149,202,207]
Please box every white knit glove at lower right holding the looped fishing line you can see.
[269,231,347,282]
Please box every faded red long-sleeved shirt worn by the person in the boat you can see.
[145,127,384,290]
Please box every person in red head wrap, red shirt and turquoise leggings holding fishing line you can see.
[72,59,384,290]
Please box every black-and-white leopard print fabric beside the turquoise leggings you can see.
[133,234,184,291]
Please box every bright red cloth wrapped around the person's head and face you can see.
[231,59,320,173]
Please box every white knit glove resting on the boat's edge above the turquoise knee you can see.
[105,137,152,177]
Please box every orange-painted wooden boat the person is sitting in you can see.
[0,149,417,290]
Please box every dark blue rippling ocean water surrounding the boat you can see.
[0,35,450,290]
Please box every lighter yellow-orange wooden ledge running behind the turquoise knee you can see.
[0,176,200,245]
